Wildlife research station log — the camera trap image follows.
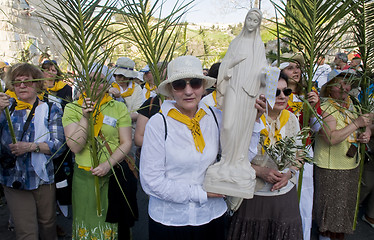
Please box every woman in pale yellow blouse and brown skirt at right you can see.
[314,70,371,239]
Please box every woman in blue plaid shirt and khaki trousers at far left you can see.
[0,63,65,239]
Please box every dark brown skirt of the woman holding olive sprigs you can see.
[228,187,303,240]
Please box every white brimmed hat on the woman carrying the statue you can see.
[158,56,216,97]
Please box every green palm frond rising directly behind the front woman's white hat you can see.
[118,0,193,90]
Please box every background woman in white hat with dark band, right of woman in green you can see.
[109,57,143,122]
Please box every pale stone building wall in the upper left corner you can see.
[0,0,63,64]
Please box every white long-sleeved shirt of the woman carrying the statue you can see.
[140,101,227,226]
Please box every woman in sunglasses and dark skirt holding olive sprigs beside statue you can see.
[228,74,303,240]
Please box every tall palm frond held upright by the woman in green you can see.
[35,0,117,216]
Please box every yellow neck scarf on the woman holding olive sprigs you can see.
[261,110,290,153]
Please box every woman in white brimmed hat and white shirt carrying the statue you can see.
[140,56,265,240]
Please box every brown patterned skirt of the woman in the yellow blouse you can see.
[313,166,359,233]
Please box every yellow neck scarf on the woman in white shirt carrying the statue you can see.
[168,108,206,153]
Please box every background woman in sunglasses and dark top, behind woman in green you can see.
[42,60,72,109]
